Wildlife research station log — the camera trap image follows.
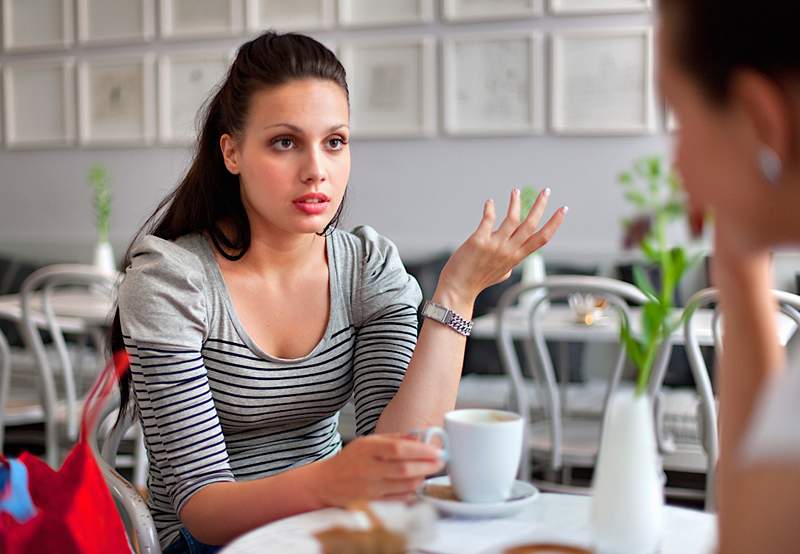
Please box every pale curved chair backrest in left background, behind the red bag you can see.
[20,264,115,467]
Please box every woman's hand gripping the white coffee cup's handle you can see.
[312,435,444,506]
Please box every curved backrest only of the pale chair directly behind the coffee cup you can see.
[496,275,647,479]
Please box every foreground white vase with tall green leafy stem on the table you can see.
[592,157,692,553]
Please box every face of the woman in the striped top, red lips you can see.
[220,79,350,239]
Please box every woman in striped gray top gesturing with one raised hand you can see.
[114,33,566,552]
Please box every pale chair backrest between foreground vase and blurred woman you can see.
[683,288,800,511]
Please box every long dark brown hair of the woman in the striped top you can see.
[110,31,349,421]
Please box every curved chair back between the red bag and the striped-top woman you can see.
[88,395,161,554]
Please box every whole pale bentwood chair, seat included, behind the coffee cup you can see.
[496,275,647,492]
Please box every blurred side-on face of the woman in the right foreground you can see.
[658,14,775,242]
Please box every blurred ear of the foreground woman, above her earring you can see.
[731,70,796,163]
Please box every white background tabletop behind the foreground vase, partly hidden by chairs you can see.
[471,304,795,346]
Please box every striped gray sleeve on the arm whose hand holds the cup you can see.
[119,236,233,513]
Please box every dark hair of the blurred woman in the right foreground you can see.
[659,0,800,104]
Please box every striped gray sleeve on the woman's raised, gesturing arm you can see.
[353,227,422,435]
